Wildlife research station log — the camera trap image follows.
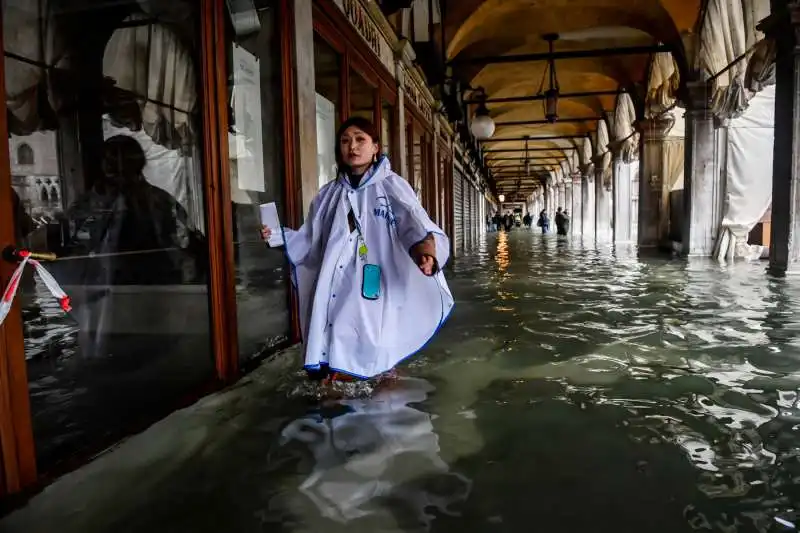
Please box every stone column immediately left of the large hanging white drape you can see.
[682,82,720,257]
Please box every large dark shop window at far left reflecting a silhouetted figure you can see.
[2,0,214,472]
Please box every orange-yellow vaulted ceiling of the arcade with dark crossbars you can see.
[443,0,702,196]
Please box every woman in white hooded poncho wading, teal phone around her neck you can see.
[262,117,453,379]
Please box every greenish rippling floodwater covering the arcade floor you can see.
[0,230,800,533]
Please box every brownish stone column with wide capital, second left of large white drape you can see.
[636,114,675,248]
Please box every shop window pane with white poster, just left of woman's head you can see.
[314,35,342,187]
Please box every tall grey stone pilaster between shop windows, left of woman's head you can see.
[290,2,319,218]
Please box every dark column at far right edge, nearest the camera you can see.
[758,2,800,276]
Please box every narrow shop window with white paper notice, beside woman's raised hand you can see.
[226,0,291,361]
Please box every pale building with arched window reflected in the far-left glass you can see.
[8,131,63,217]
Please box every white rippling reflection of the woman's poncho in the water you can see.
[282,378,471,531]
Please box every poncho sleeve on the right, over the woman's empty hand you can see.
[386,175,450,268]
